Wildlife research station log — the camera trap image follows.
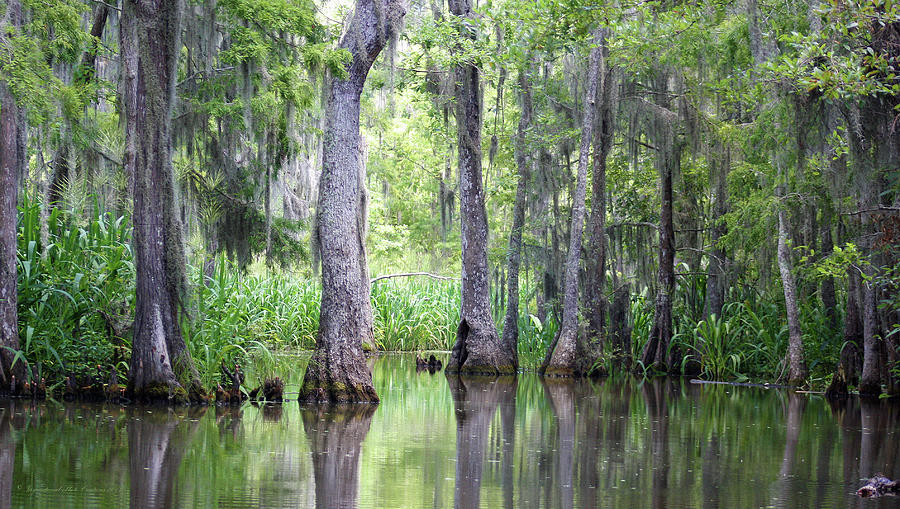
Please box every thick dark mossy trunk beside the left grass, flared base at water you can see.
[120,0,202,401]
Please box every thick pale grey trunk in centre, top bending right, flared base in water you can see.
[300,0,405,402]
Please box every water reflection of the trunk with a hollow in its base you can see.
[447,376,517,509]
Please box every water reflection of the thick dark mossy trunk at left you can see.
[128,407,206,509]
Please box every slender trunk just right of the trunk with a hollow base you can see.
[502,65,534,369]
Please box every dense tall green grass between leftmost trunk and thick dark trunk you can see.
[18,199,135,378]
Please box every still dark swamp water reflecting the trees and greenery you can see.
[0,355,900,509]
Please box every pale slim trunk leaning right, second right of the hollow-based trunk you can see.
[539,30,603,376]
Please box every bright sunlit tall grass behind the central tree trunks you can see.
[195,266,556,367]
